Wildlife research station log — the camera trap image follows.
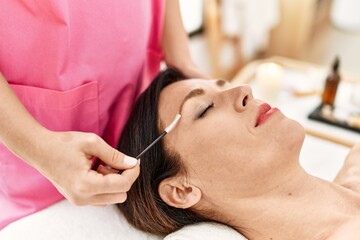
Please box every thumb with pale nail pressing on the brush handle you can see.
[89,137,137,170]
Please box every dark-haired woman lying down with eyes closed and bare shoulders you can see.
[113,69,360,240]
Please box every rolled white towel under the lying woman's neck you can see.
[164,223,246,240]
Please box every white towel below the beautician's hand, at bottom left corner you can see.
[0,200,161,240]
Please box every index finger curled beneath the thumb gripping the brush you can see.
[88,165,140,195]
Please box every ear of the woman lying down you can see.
[158,177,201,209]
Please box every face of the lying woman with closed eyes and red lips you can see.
[159,79,304,199]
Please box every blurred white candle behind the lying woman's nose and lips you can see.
[255,63,284,104]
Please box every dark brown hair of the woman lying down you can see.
[118,68,209,235]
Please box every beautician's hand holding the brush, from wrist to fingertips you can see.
[35,131,140,205]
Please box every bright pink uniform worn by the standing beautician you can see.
[0,0,164,229]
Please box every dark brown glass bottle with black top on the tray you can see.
[322,57,341,107]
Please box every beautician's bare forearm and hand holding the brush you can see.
[0,73,140,205]
